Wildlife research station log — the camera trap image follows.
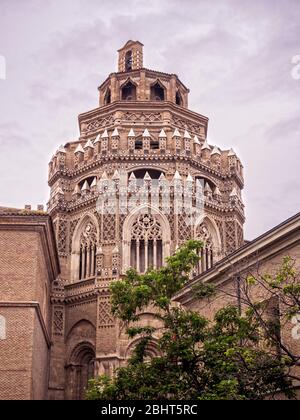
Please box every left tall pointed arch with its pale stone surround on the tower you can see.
[71,213,99,282]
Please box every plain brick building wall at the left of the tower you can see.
[0,220,57,400]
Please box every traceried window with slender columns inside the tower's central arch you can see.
[130,213,163,273]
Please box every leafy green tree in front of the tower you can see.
[87,241,293,400]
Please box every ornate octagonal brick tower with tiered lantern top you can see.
[48,41,244,399]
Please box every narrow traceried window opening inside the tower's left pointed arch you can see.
[78,222,97,280]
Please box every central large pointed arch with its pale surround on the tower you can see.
[123,204,171,273]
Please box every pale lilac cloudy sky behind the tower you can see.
[0,0,300,239]
